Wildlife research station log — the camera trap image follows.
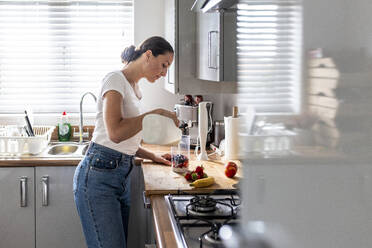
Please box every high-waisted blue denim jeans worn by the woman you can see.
[73,142,134,248]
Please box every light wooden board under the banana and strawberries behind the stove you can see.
[142,143,242,195]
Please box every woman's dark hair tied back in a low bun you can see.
[121,36,174,64]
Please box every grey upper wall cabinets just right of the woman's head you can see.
[164,0,236,94]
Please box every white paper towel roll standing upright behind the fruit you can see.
[224,116,240,160]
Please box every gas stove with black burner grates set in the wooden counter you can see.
[165,191,240,248]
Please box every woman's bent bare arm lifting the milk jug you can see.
[103,90,179,143]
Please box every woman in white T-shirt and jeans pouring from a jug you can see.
[74,37,179,248]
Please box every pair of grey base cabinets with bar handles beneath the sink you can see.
[0,166,86,248]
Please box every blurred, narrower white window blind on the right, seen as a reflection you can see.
[237,0,302,114]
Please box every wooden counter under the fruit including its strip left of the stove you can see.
[142,145,243,248]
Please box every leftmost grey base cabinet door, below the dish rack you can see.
[0,167,35,248]
